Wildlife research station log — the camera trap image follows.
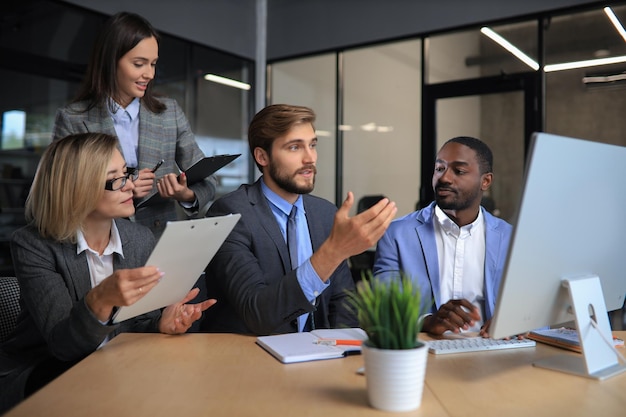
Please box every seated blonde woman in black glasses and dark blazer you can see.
[0,133,215,414]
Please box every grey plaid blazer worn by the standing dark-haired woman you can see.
[53,98,216,237]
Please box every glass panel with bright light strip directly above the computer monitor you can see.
[544,6,626,145]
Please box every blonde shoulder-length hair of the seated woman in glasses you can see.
[26,133,117,243]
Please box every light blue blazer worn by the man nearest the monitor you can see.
[373,202,513,320]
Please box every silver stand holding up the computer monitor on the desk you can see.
[533,275,626,380]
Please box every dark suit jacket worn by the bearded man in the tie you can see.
[202,179,358,335]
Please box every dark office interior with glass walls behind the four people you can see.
[0,0,626,330]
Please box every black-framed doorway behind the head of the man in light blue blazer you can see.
[418,72,543,222]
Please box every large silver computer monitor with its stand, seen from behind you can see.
[489,133,626,379]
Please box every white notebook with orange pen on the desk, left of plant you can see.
[256,328,367,363]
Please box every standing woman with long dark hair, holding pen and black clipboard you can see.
[53,12,215,237]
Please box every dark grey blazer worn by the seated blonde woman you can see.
[0,219,161,410]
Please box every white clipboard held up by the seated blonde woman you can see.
[113,214,241,323]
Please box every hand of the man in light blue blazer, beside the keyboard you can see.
[422,299,480,335]
